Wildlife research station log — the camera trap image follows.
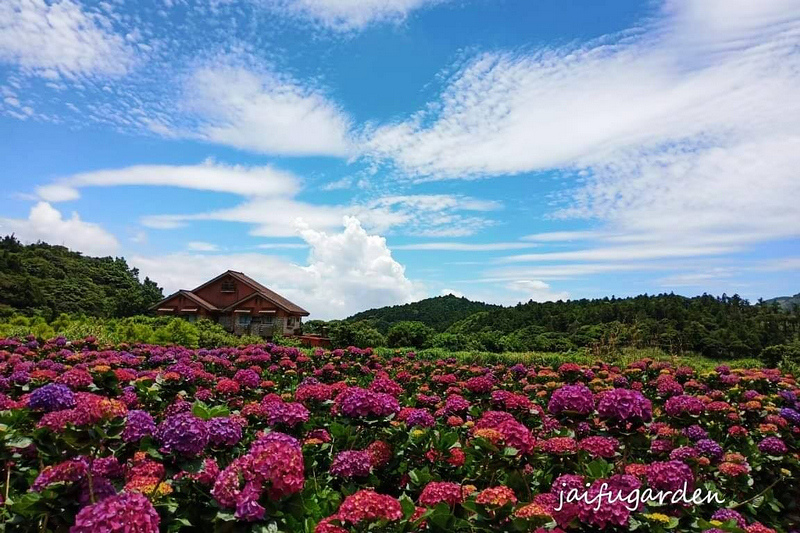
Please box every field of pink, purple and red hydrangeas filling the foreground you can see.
[0,338,800,533]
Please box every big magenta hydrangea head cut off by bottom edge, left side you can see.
[69,492,160,533]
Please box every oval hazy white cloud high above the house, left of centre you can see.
[185,56,351,157]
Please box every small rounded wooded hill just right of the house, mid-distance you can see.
[347,294,502,334]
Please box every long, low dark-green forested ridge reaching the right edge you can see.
[447,294,800,357]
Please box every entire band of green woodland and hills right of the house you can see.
[340,294,800,365]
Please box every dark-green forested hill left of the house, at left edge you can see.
[0,236,163,319]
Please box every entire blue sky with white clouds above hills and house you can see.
[0,0,800,319]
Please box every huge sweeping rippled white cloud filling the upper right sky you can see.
[366,0,800,270]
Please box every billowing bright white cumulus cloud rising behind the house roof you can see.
[130,218,426,319]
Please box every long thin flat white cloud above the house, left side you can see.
[36,161,300,202]
